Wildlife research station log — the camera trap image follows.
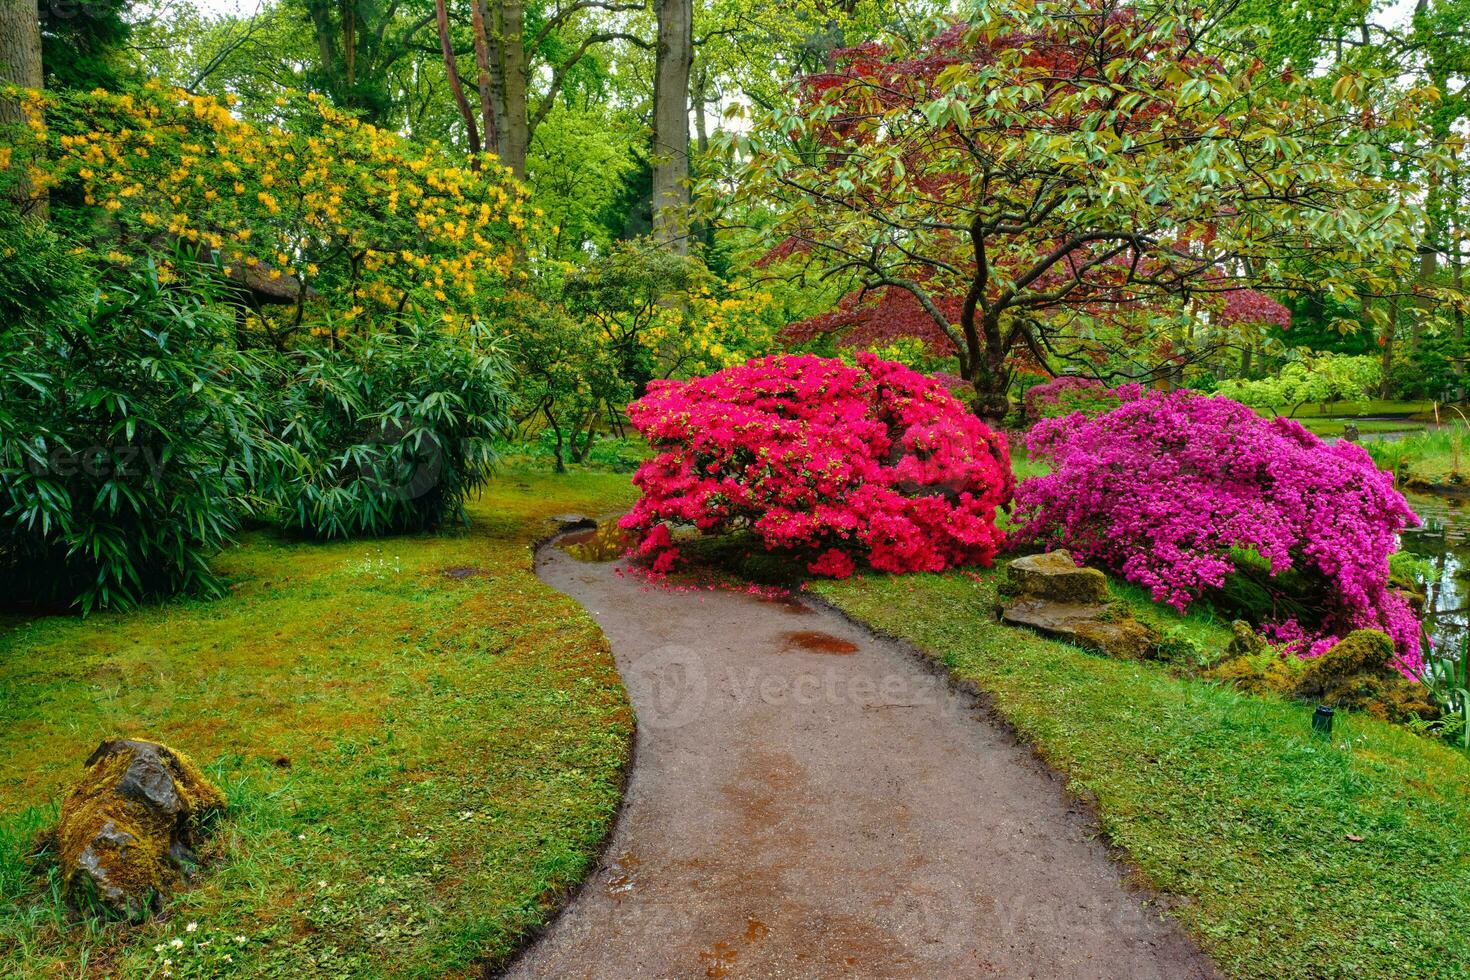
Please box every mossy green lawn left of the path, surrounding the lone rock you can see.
[0,473,632,977]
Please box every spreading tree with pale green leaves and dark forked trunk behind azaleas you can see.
[726,0,1423,417]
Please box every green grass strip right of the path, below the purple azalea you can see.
[811,572,1470,977]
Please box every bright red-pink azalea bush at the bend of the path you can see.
[620,354,1014,577]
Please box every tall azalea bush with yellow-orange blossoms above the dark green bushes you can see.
[0,84,528,345]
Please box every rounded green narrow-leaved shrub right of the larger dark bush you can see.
[260,325,512,538]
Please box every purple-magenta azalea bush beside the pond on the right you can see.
[1016,388,1420,673]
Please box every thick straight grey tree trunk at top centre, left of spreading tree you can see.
[653,0,694,256]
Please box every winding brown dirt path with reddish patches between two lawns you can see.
[506,547,1217,980]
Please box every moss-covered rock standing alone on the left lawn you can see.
[56,739,225,921]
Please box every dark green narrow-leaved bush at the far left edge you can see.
[0,233,254,611]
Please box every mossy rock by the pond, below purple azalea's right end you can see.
[1294,629,1439,721]
